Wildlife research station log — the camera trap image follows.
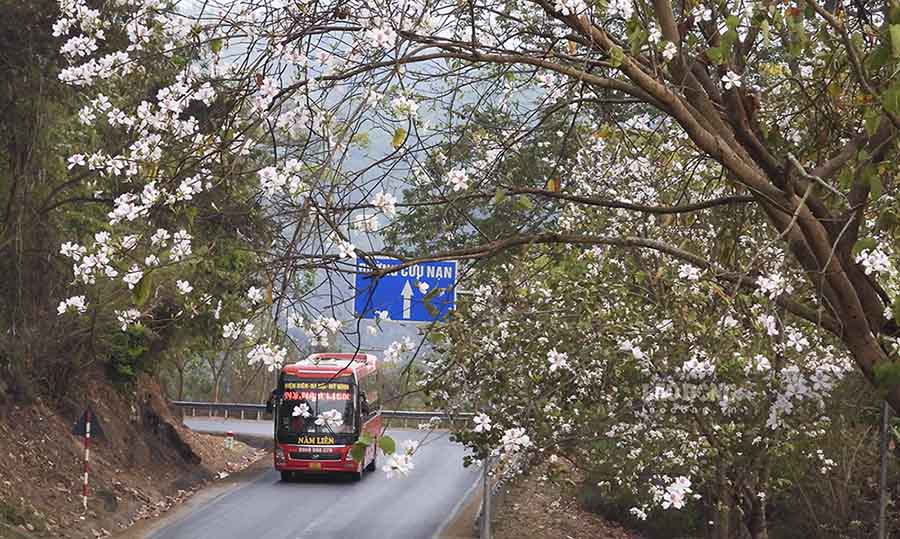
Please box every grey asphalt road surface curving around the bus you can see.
[148,418,480,539]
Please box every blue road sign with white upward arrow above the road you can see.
[354,258,456,322]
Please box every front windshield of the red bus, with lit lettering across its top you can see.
[278,380,354,435]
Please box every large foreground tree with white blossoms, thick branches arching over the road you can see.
[45,0,900,520]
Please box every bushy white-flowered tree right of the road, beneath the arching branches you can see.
[427,248,858,537]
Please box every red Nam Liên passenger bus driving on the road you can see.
[271,353,381,481]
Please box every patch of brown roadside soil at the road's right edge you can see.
[492,461,640,539]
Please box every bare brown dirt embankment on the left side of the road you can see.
[0,378,263,539]
